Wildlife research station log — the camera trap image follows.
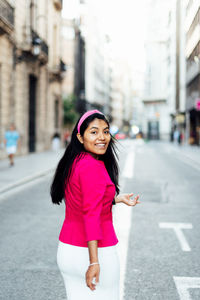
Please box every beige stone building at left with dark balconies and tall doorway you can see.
[0,0,65,157]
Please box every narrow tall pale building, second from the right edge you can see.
[167,0,187,142]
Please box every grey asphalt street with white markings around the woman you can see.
[0,140,200,300]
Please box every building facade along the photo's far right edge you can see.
[185,0,200,145]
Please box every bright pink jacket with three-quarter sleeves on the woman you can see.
[59,153,118,247]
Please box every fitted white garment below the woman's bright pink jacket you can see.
[57,242,120,300]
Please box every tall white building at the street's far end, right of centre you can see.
[143,0,170,140]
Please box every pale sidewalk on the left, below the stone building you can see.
[0,149,64,194]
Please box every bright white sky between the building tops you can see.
[63,0,146,70]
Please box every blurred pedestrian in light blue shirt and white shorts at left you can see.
[4,124,19,166]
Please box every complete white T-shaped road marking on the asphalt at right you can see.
[159,223,193,251]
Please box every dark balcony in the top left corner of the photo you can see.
[0,0,14,34]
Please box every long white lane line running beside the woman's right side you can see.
[113,150,135,300]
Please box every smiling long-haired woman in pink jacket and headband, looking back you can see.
[51,110,139,300]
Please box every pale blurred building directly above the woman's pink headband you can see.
[69,0,111,116]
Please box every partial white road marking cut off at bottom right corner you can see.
[173,276,200,300]
